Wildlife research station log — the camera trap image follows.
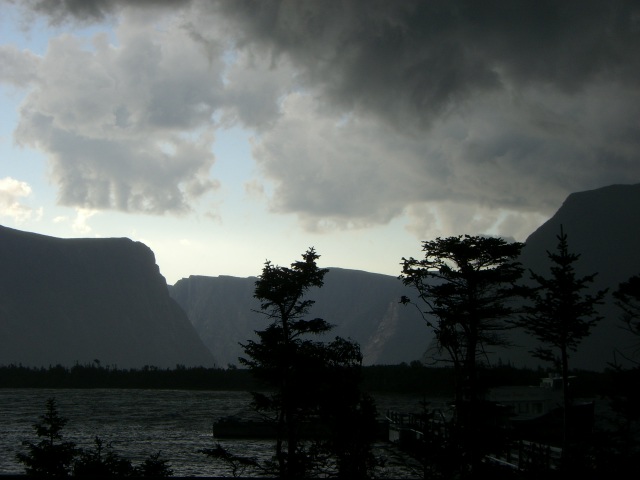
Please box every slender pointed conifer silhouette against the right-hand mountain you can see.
[516,227,606,456]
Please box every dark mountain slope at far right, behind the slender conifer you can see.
[505,184,640,370]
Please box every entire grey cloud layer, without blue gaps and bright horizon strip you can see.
[6,0,640,236]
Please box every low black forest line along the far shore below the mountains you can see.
[0,362,612,396]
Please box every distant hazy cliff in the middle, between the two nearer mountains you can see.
[170,268,432,365]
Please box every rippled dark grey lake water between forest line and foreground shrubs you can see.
[0,389,430,478]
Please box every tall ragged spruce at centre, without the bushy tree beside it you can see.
[240,248,331,478]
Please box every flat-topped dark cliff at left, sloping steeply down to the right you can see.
[0,227,214,367]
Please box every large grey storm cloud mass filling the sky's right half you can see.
[214,0,640,229]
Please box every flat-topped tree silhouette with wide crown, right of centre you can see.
[400,235,523,474]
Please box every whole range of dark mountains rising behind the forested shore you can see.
[0,185,640,370]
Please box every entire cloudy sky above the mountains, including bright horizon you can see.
[0,0,640,283]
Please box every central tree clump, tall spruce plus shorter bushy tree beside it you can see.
[240,248,375,478]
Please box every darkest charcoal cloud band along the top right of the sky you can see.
[222,0,640,127]
